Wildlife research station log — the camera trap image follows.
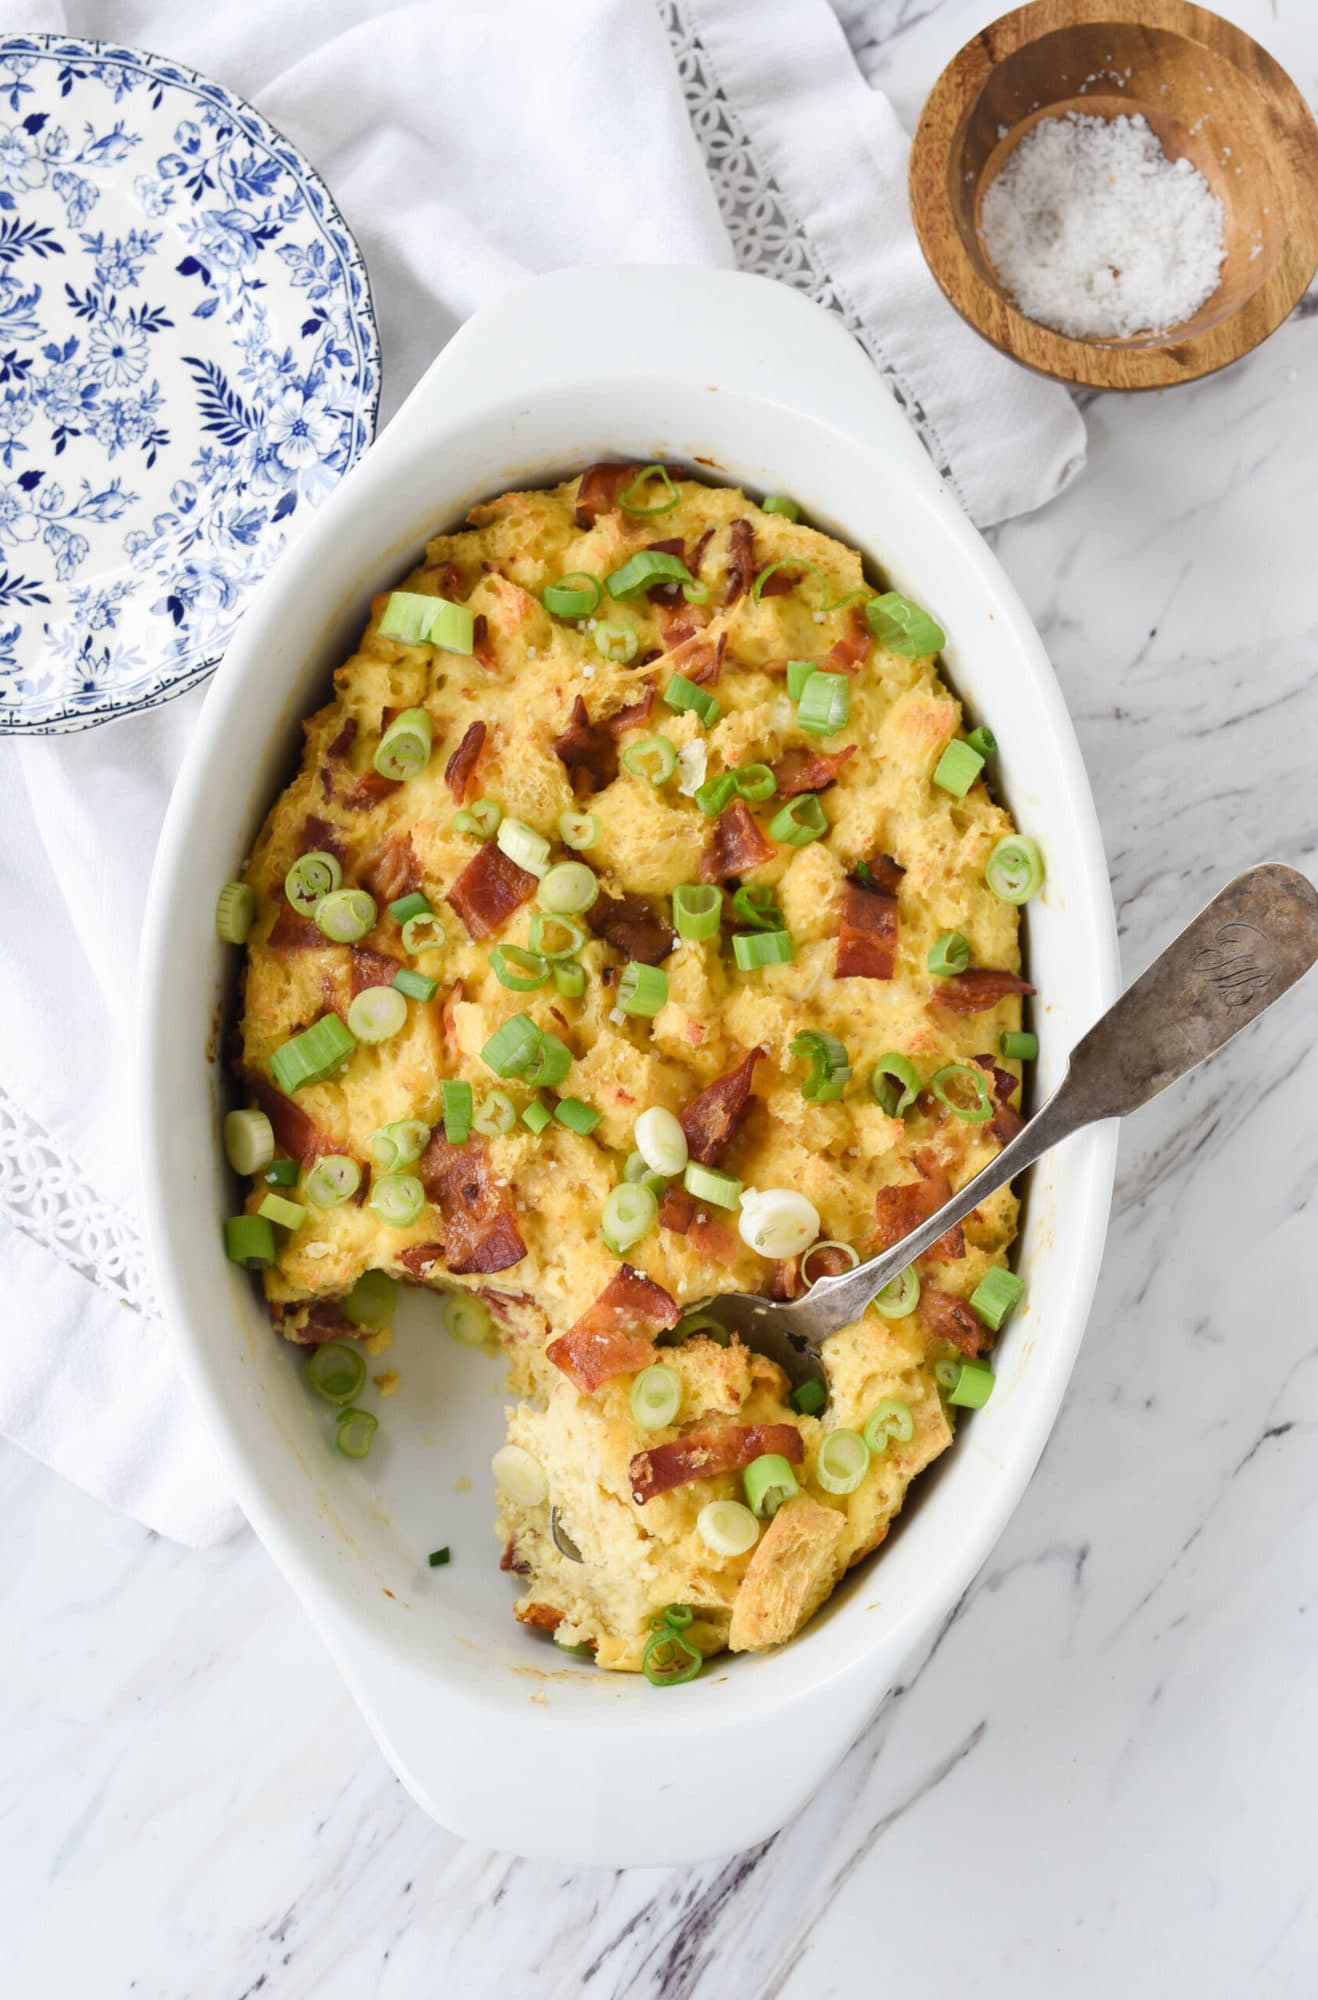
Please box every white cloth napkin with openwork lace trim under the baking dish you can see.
[0,0,1084,1544]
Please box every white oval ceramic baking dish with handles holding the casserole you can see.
[140,268,1118,1866]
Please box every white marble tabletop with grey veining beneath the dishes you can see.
[0,0,1318,2000]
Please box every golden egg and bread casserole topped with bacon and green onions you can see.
[220,464,1040,1684]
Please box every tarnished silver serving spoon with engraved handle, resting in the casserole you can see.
[700,862,1318,1388]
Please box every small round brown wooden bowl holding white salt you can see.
[910,0,1318,388]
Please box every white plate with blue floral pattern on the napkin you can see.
[0,34,380,736]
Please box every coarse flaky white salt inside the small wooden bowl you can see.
[980,112,1226,340]
